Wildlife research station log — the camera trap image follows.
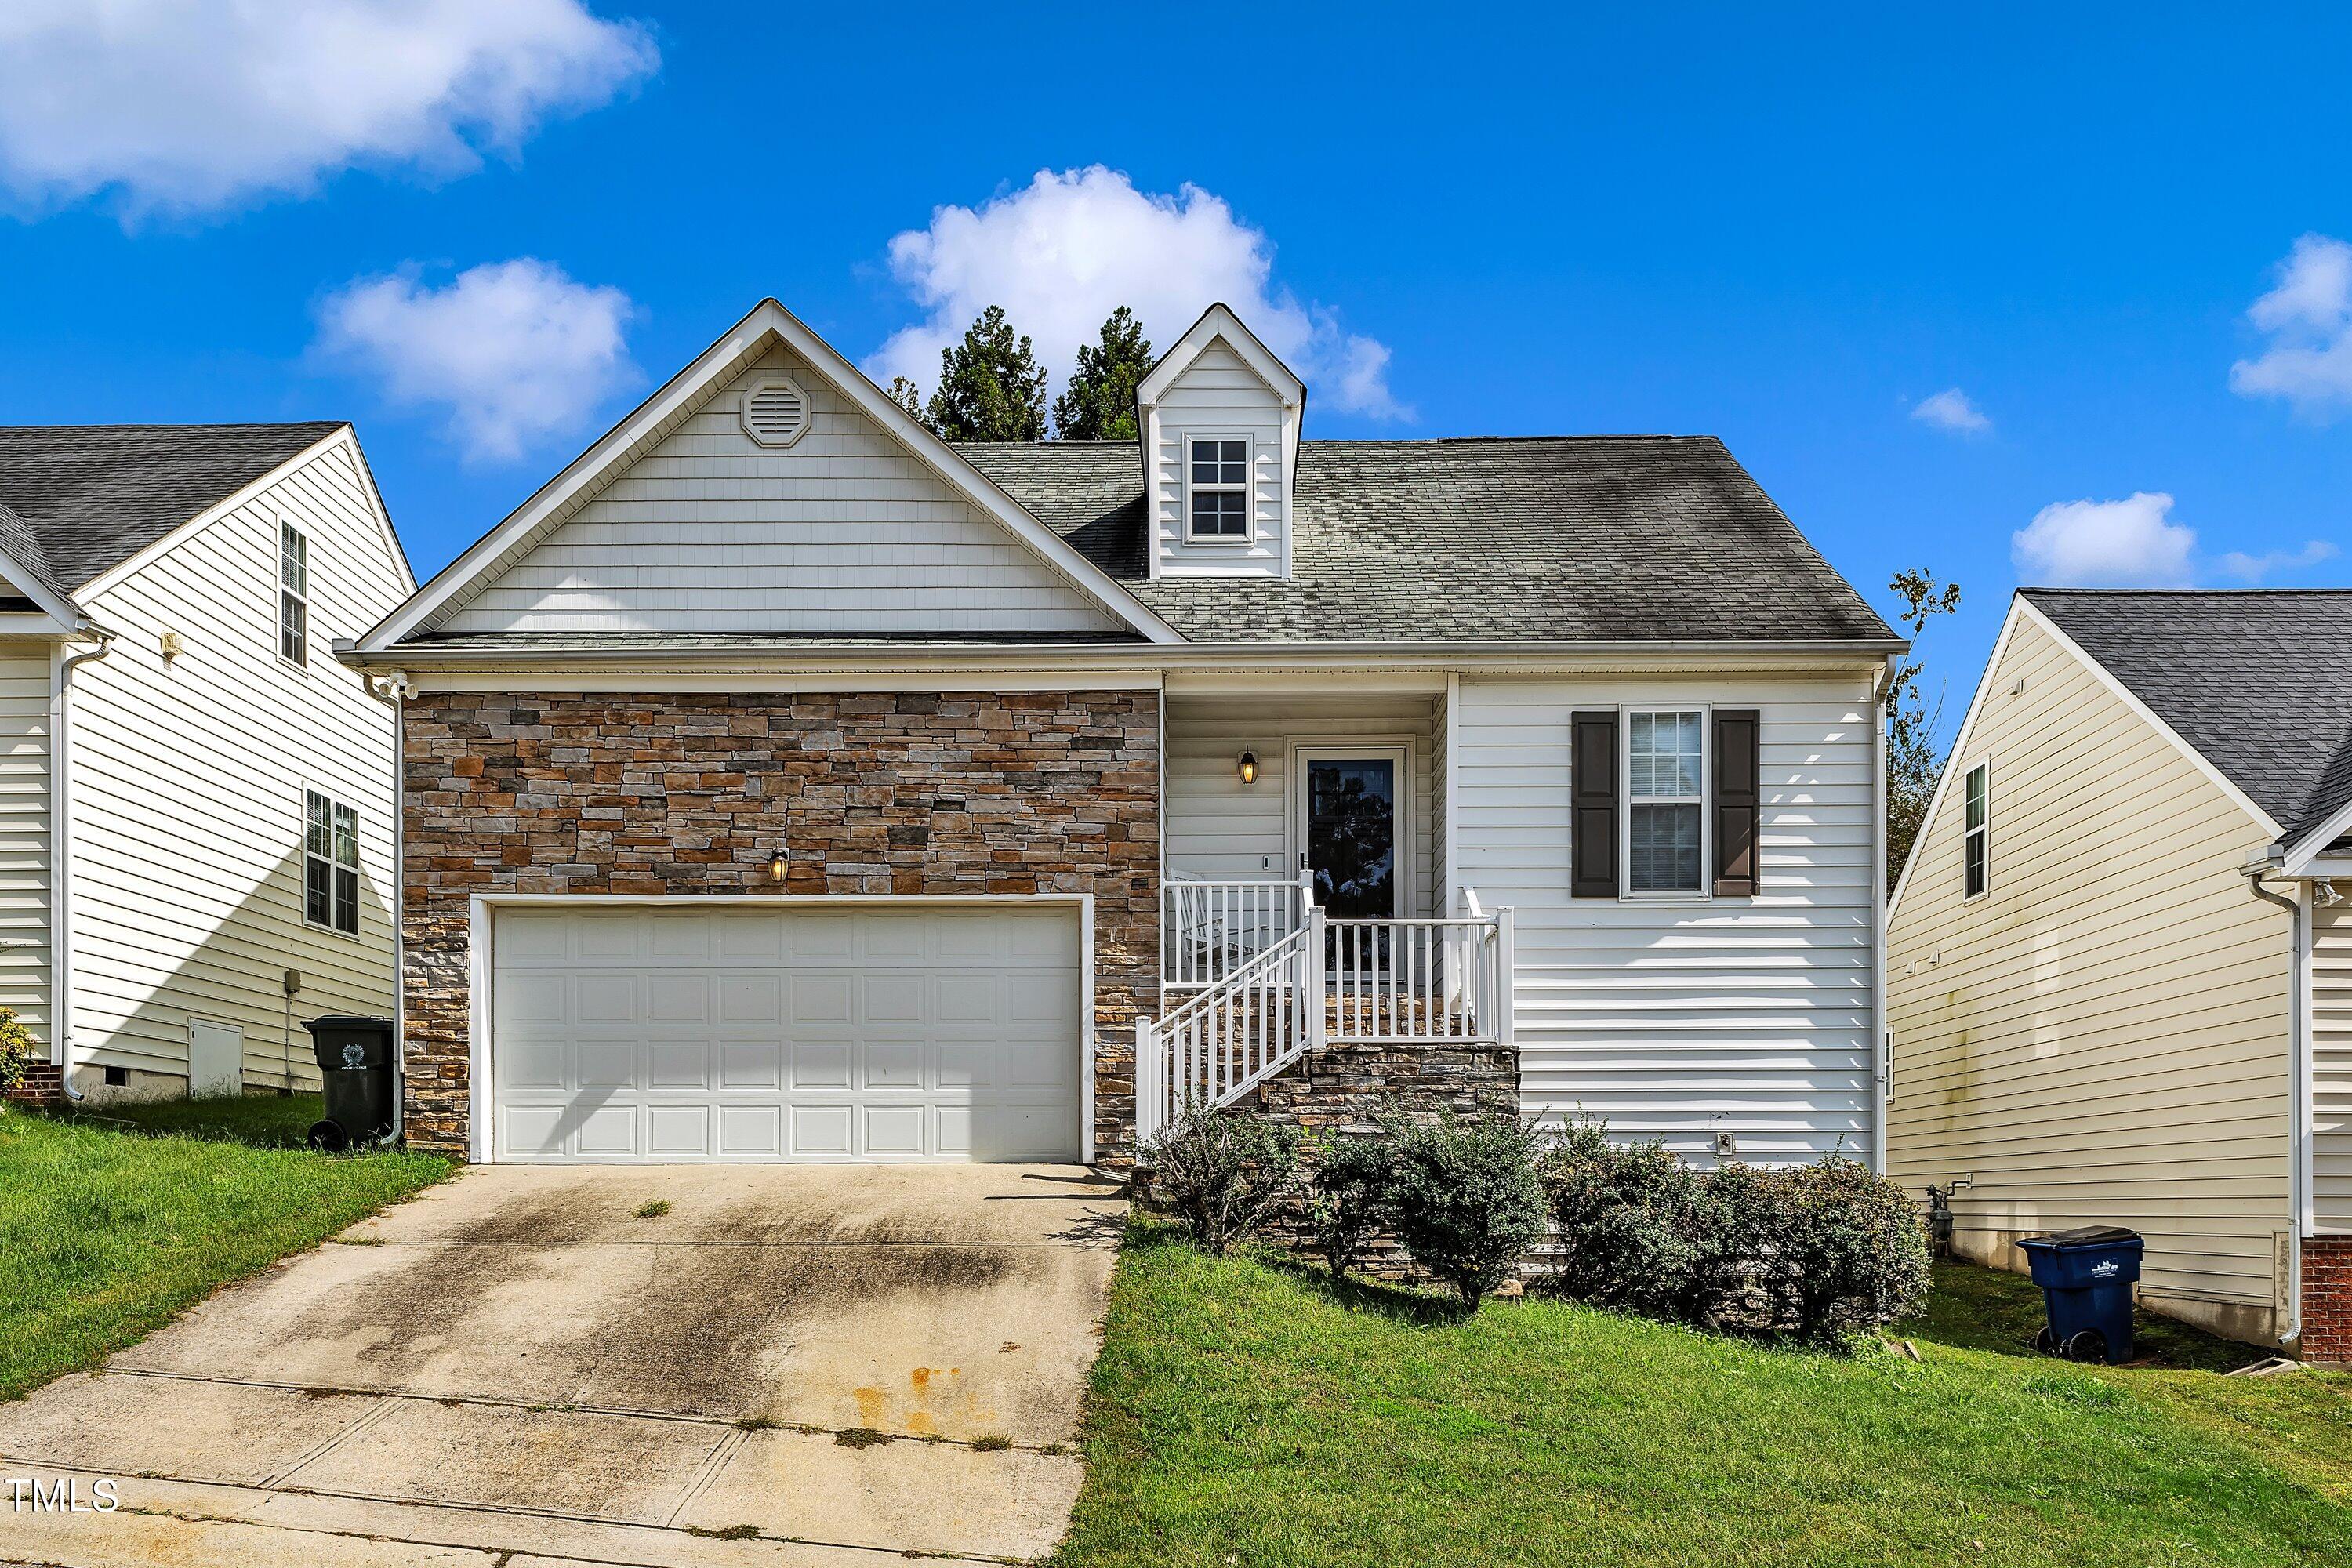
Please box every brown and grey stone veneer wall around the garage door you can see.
[402,691,1160,1163]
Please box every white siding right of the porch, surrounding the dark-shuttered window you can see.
[1449,673,1875,1163]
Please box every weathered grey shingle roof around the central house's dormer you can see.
[957,435,1893,642]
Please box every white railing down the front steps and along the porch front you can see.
[1136,905,1512,1140]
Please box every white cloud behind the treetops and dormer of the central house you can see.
[866,165,1414,419]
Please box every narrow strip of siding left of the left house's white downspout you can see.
[0,642,54,1048]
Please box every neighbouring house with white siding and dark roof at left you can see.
[0,423,414,1095]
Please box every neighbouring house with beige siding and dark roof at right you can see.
[1889,588,2352,1361]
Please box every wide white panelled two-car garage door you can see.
[489,905,1084,1161]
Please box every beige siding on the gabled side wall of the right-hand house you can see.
[1889,612,2288,1328]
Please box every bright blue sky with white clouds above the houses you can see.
[0,0,2352,706]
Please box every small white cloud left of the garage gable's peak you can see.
[318,256,637,461]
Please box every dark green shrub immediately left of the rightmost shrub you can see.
[1543,1119,1708,1316]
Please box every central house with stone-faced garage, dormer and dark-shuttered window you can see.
[346,301,1903,1163]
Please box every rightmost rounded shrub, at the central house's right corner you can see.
[1693,1154,1929,1345]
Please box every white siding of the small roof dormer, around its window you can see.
[1148,341,1289,576]
